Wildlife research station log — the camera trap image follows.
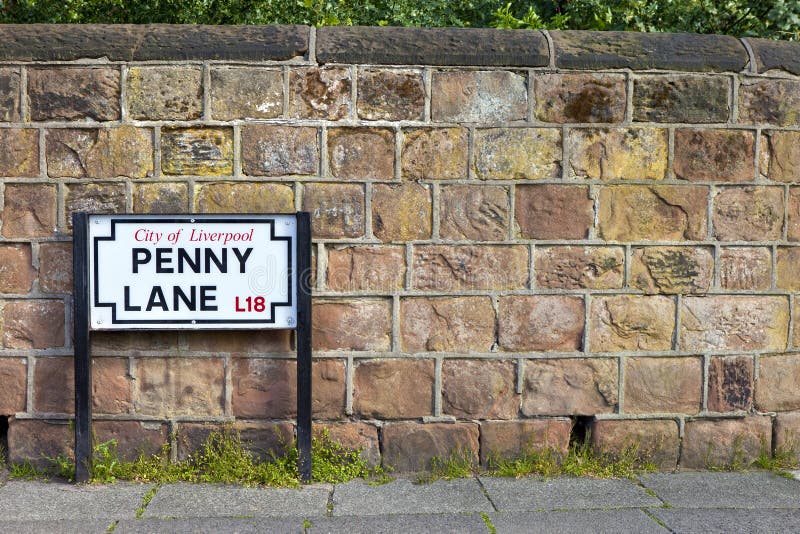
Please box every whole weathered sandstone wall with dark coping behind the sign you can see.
[0,26,800,470]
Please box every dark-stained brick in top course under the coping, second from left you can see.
[28,67,120,121]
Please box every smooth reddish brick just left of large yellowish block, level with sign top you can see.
[514,184,594,239]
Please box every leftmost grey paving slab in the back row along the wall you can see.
[0,480,152,521]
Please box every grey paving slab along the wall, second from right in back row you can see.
[481,477,663,511]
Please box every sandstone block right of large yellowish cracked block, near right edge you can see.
[711,186,783,241]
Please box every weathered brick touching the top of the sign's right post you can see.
[303,183,365,238]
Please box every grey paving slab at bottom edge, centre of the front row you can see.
[308,514,487,534]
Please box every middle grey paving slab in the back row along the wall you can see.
[333,478,494,516]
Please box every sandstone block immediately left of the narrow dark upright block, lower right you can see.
[625,357,703,415]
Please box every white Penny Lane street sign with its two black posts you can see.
[72,212,311,482]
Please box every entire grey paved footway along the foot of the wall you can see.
[0,472,800,534]
